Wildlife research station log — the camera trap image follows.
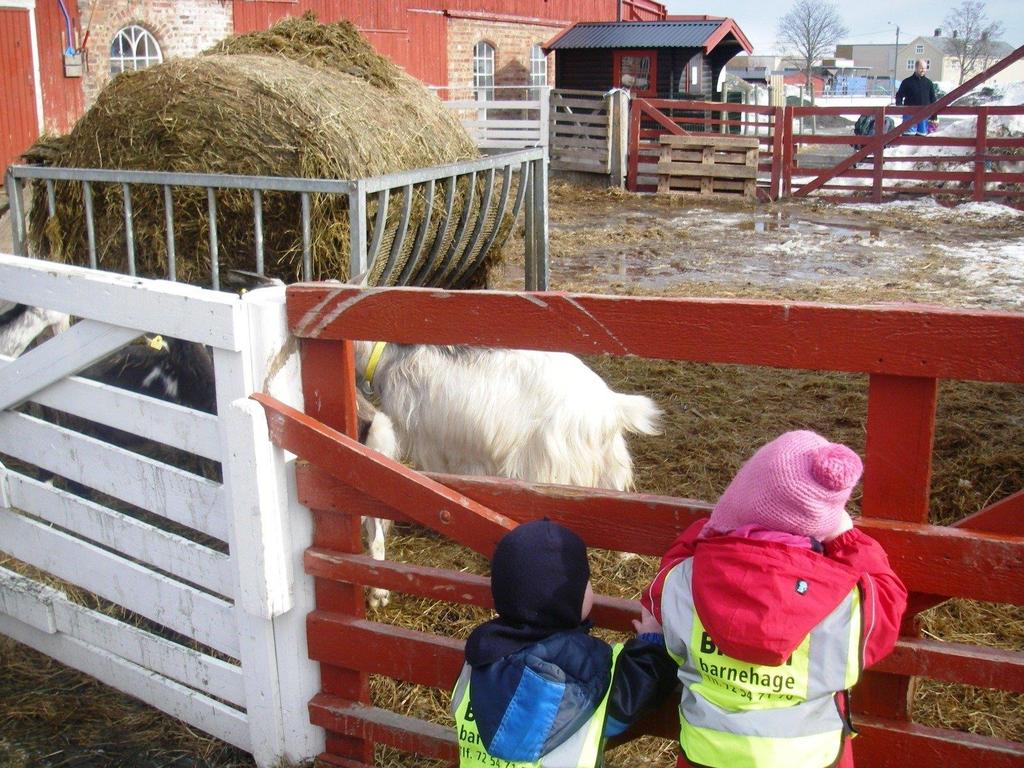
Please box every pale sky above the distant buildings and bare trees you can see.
[662,0,1024,54]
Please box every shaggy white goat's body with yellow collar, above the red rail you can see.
[355,342,660,490]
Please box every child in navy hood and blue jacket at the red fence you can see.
[453,520,675,768]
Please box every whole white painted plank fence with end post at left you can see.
[0,254,324,766]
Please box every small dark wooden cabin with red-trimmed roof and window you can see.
[544,16,754,101]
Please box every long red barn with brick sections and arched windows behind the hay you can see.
[0,0,666,170]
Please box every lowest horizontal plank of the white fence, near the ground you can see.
[0,614,251,752]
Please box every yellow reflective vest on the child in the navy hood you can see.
[452,643,623,768]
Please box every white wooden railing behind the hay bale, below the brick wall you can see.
[431,85,551,150]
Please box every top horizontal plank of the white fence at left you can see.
[0,253,242,350]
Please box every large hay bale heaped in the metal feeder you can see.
[29,16,507,284]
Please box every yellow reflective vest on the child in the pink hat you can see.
[662,558,860,768]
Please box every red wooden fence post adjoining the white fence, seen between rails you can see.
[302,339,374,765]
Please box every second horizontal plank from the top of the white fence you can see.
[0,355,221,461]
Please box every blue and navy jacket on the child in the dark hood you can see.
[462,627,676,762]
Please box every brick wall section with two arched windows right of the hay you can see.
[447,16,564,88]
